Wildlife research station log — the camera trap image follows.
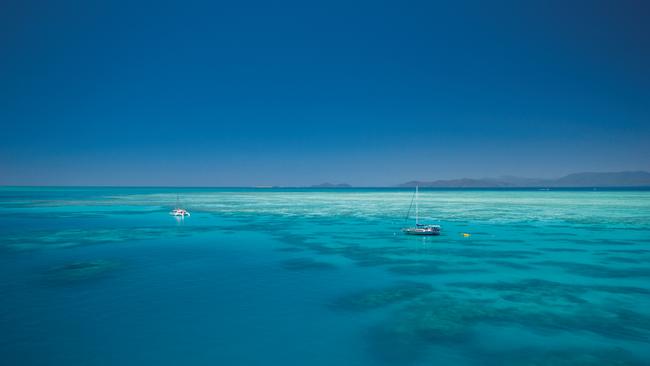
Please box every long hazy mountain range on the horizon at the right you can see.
[398,171,650,188]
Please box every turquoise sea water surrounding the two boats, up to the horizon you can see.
[0,187,650,365]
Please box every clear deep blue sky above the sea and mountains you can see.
[0,0,650,186]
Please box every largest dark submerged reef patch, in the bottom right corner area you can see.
[368,290,650,363]
